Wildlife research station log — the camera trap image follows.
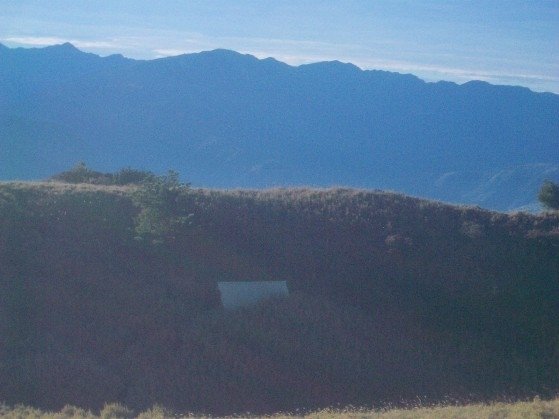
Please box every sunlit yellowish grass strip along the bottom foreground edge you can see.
[0,397,559,419]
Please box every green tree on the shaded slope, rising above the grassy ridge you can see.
[133,170,192,244]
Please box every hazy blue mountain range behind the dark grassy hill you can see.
[0,44,559,210]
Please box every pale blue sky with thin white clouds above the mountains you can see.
[0,0,559,93]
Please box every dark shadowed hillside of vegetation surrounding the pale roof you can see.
[0,178,559,414]
